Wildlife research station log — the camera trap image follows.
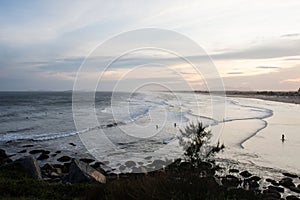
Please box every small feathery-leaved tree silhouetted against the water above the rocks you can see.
[179,122,225,167]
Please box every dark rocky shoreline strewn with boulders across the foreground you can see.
[0,146,300,200]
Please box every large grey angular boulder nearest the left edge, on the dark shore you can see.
[11,156,42,180]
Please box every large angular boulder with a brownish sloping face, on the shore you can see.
[64,159,106,183]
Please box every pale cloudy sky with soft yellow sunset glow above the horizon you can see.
[0,0,300,91]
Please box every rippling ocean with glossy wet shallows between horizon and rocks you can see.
[0,91,300,177]
